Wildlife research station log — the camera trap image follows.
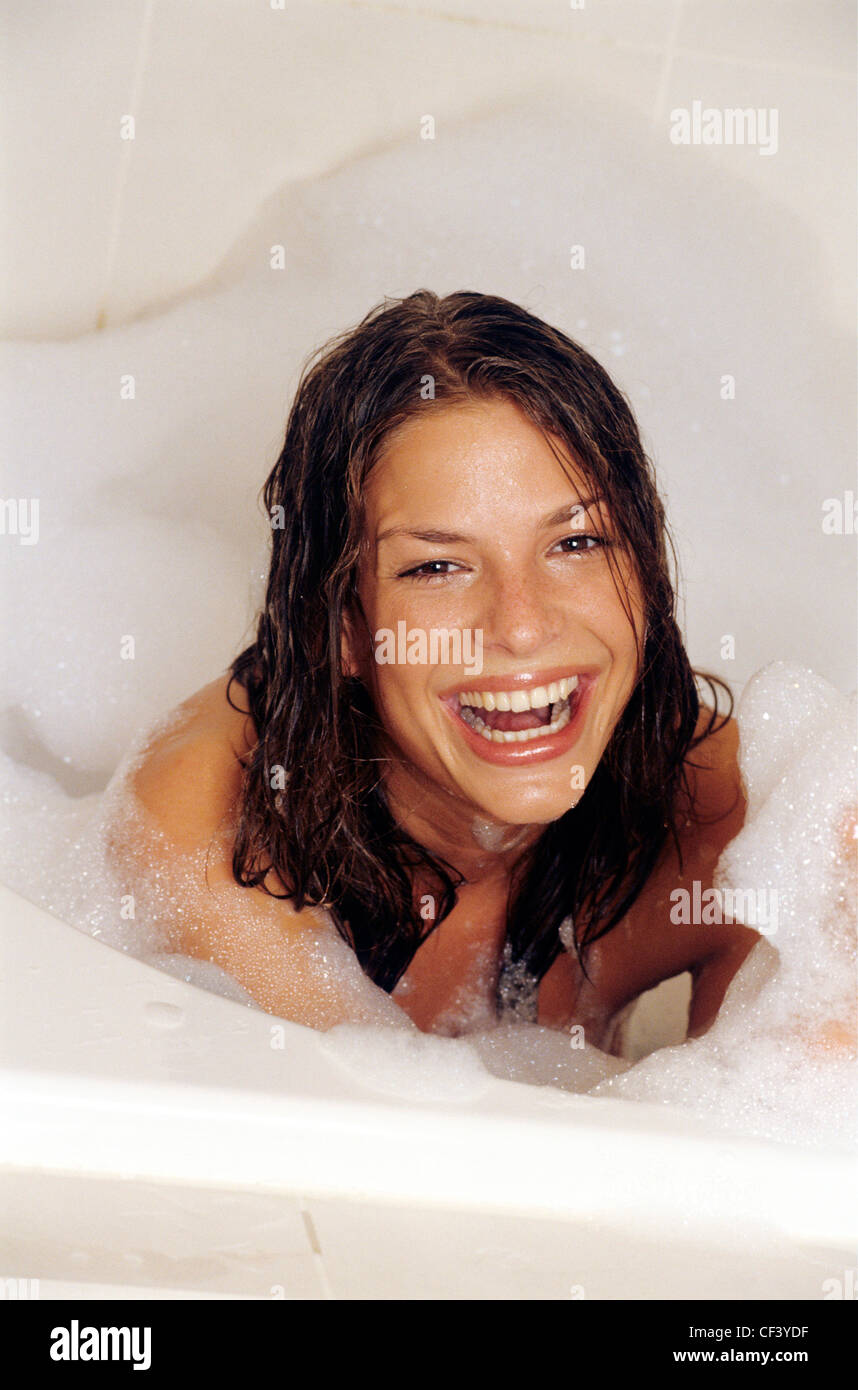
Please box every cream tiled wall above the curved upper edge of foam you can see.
[1,0,854,336]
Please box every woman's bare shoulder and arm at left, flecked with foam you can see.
[108,677,406,1029]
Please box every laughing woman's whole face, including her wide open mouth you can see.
[345,400,642,826]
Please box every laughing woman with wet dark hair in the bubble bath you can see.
[114,291,759,1048]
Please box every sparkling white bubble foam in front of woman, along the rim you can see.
[0,663,858,1145]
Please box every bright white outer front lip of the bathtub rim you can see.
[0,1073,858,1252]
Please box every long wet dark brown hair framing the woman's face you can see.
[229,291,733,1004]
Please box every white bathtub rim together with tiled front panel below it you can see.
[0,888,858,1300]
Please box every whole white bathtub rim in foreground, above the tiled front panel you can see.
[0,890,858,1248]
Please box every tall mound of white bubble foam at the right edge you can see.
[591,662,858,1145]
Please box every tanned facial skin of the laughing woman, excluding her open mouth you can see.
[345,402,641,839]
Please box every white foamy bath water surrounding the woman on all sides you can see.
[0,96,858,1144]
